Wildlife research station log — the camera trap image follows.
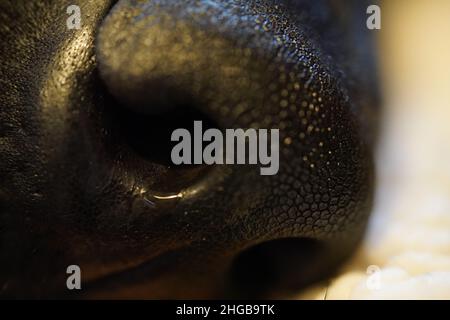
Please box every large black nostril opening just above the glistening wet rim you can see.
[100,84,217,194]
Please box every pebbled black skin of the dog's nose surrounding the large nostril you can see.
[0,0,376,298]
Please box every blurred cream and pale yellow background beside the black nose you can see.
[298,0,450,299]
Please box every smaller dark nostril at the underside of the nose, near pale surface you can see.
[230,238,323,298]
